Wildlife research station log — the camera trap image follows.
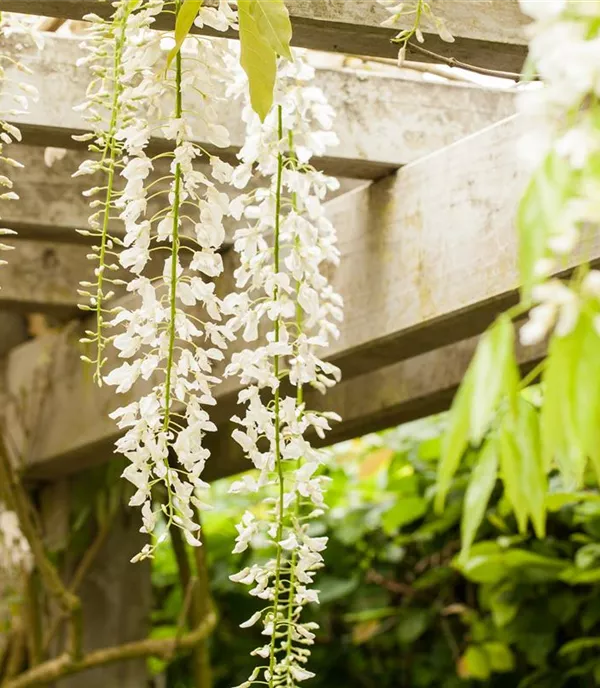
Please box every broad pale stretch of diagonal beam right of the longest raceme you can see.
[217,117,532,420]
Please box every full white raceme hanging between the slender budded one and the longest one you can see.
[98,2,233,558]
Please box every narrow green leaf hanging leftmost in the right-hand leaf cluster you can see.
[434,367,473,513]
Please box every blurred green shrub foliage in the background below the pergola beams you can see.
[152,417,600,688]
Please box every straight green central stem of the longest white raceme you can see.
[269,105,285,688]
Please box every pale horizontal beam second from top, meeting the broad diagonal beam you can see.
[0,35,515,179]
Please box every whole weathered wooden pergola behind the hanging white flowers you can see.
[0,0,564,688]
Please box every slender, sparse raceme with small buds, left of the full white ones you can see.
[73,0,162,385]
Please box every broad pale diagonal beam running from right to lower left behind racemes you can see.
[0,118,548,478]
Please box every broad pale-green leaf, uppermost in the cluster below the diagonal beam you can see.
[470,315,518,445]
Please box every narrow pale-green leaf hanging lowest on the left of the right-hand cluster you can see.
[460,439,498,557]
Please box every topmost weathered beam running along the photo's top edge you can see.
[0,0,527,72]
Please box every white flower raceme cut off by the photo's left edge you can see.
[0,12,42,284]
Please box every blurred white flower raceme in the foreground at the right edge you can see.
[518,0,600,344]
